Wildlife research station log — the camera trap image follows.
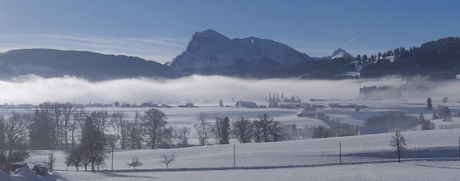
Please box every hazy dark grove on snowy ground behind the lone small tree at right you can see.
[364,111,425,130]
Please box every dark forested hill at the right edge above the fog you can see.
[361,37,460,79]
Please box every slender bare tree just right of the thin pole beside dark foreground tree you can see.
[110,111,129,150]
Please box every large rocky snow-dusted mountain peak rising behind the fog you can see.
[167,29,312,74]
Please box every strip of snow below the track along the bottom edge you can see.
[49,161,460,181]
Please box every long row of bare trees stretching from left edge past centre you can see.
[0,102,289,170]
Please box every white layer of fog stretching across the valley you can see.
[0,75,460,104]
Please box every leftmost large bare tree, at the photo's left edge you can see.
[5,111,32,160]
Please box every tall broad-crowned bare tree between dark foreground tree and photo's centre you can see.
[144,109,168,149]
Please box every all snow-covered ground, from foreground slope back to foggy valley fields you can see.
[0,75,460,181]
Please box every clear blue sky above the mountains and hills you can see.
[0,0,460,63]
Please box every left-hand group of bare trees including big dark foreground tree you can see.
[0,102,190,170]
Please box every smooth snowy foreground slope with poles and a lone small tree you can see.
[0,129,460,181]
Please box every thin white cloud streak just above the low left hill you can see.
[0,33,189,63]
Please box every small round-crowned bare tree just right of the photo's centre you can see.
[232,117,253,143]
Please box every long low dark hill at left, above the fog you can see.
[0,49,183,81]
